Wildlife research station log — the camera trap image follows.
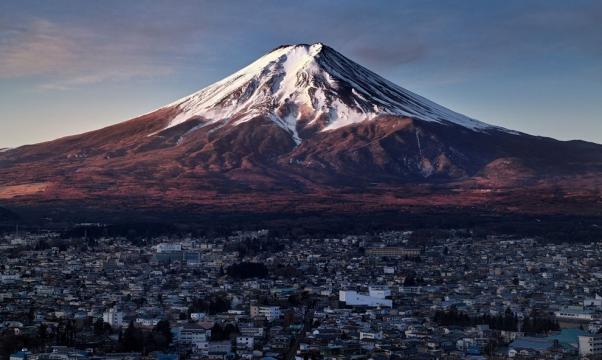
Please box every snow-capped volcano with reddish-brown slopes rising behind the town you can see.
[0,43,602,219]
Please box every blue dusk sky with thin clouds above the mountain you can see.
[0,0,602,148]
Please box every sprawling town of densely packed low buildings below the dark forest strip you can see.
[0,230,602,360]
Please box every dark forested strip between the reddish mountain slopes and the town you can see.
[0,204,602,243]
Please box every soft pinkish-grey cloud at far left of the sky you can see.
[0,18,173,90]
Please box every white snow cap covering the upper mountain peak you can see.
[156,43,511,143]
